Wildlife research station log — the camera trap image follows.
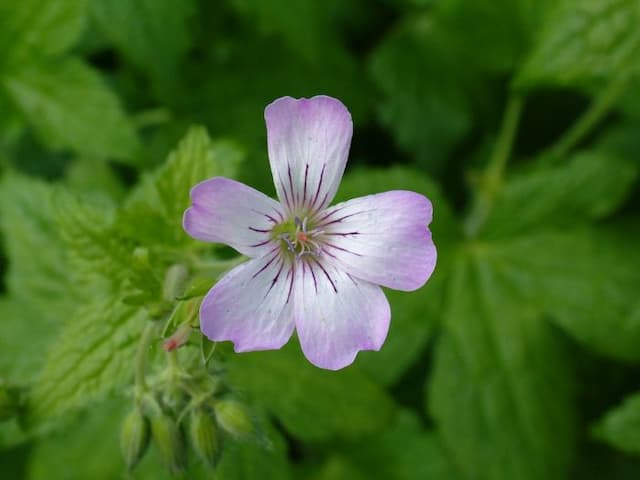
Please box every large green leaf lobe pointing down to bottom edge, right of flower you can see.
[429,253,575,480]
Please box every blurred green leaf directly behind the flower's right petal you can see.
[336,167,460,385]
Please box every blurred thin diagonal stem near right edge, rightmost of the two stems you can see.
[549,72,630,159]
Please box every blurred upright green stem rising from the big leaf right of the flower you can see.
[464,95,523,236]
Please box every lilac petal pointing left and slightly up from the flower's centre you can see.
[182,177,283,257]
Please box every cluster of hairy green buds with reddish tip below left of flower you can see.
[120,260,260,474]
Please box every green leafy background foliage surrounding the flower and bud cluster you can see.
[0,0,640,480]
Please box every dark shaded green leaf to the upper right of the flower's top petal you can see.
[370,17,474,168]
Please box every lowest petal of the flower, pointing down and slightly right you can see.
[295,260,391,370]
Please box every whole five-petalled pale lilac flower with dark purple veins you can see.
[183,96,436,370]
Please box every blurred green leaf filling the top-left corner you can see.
[0,0,87,69]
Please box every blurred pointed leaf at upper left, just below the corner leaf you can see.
[0,59,139,160]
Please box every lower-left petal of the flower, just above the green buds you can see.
[200,255,294,352]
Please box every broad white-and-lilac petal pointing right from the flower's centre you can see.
[316,190,437,291]
